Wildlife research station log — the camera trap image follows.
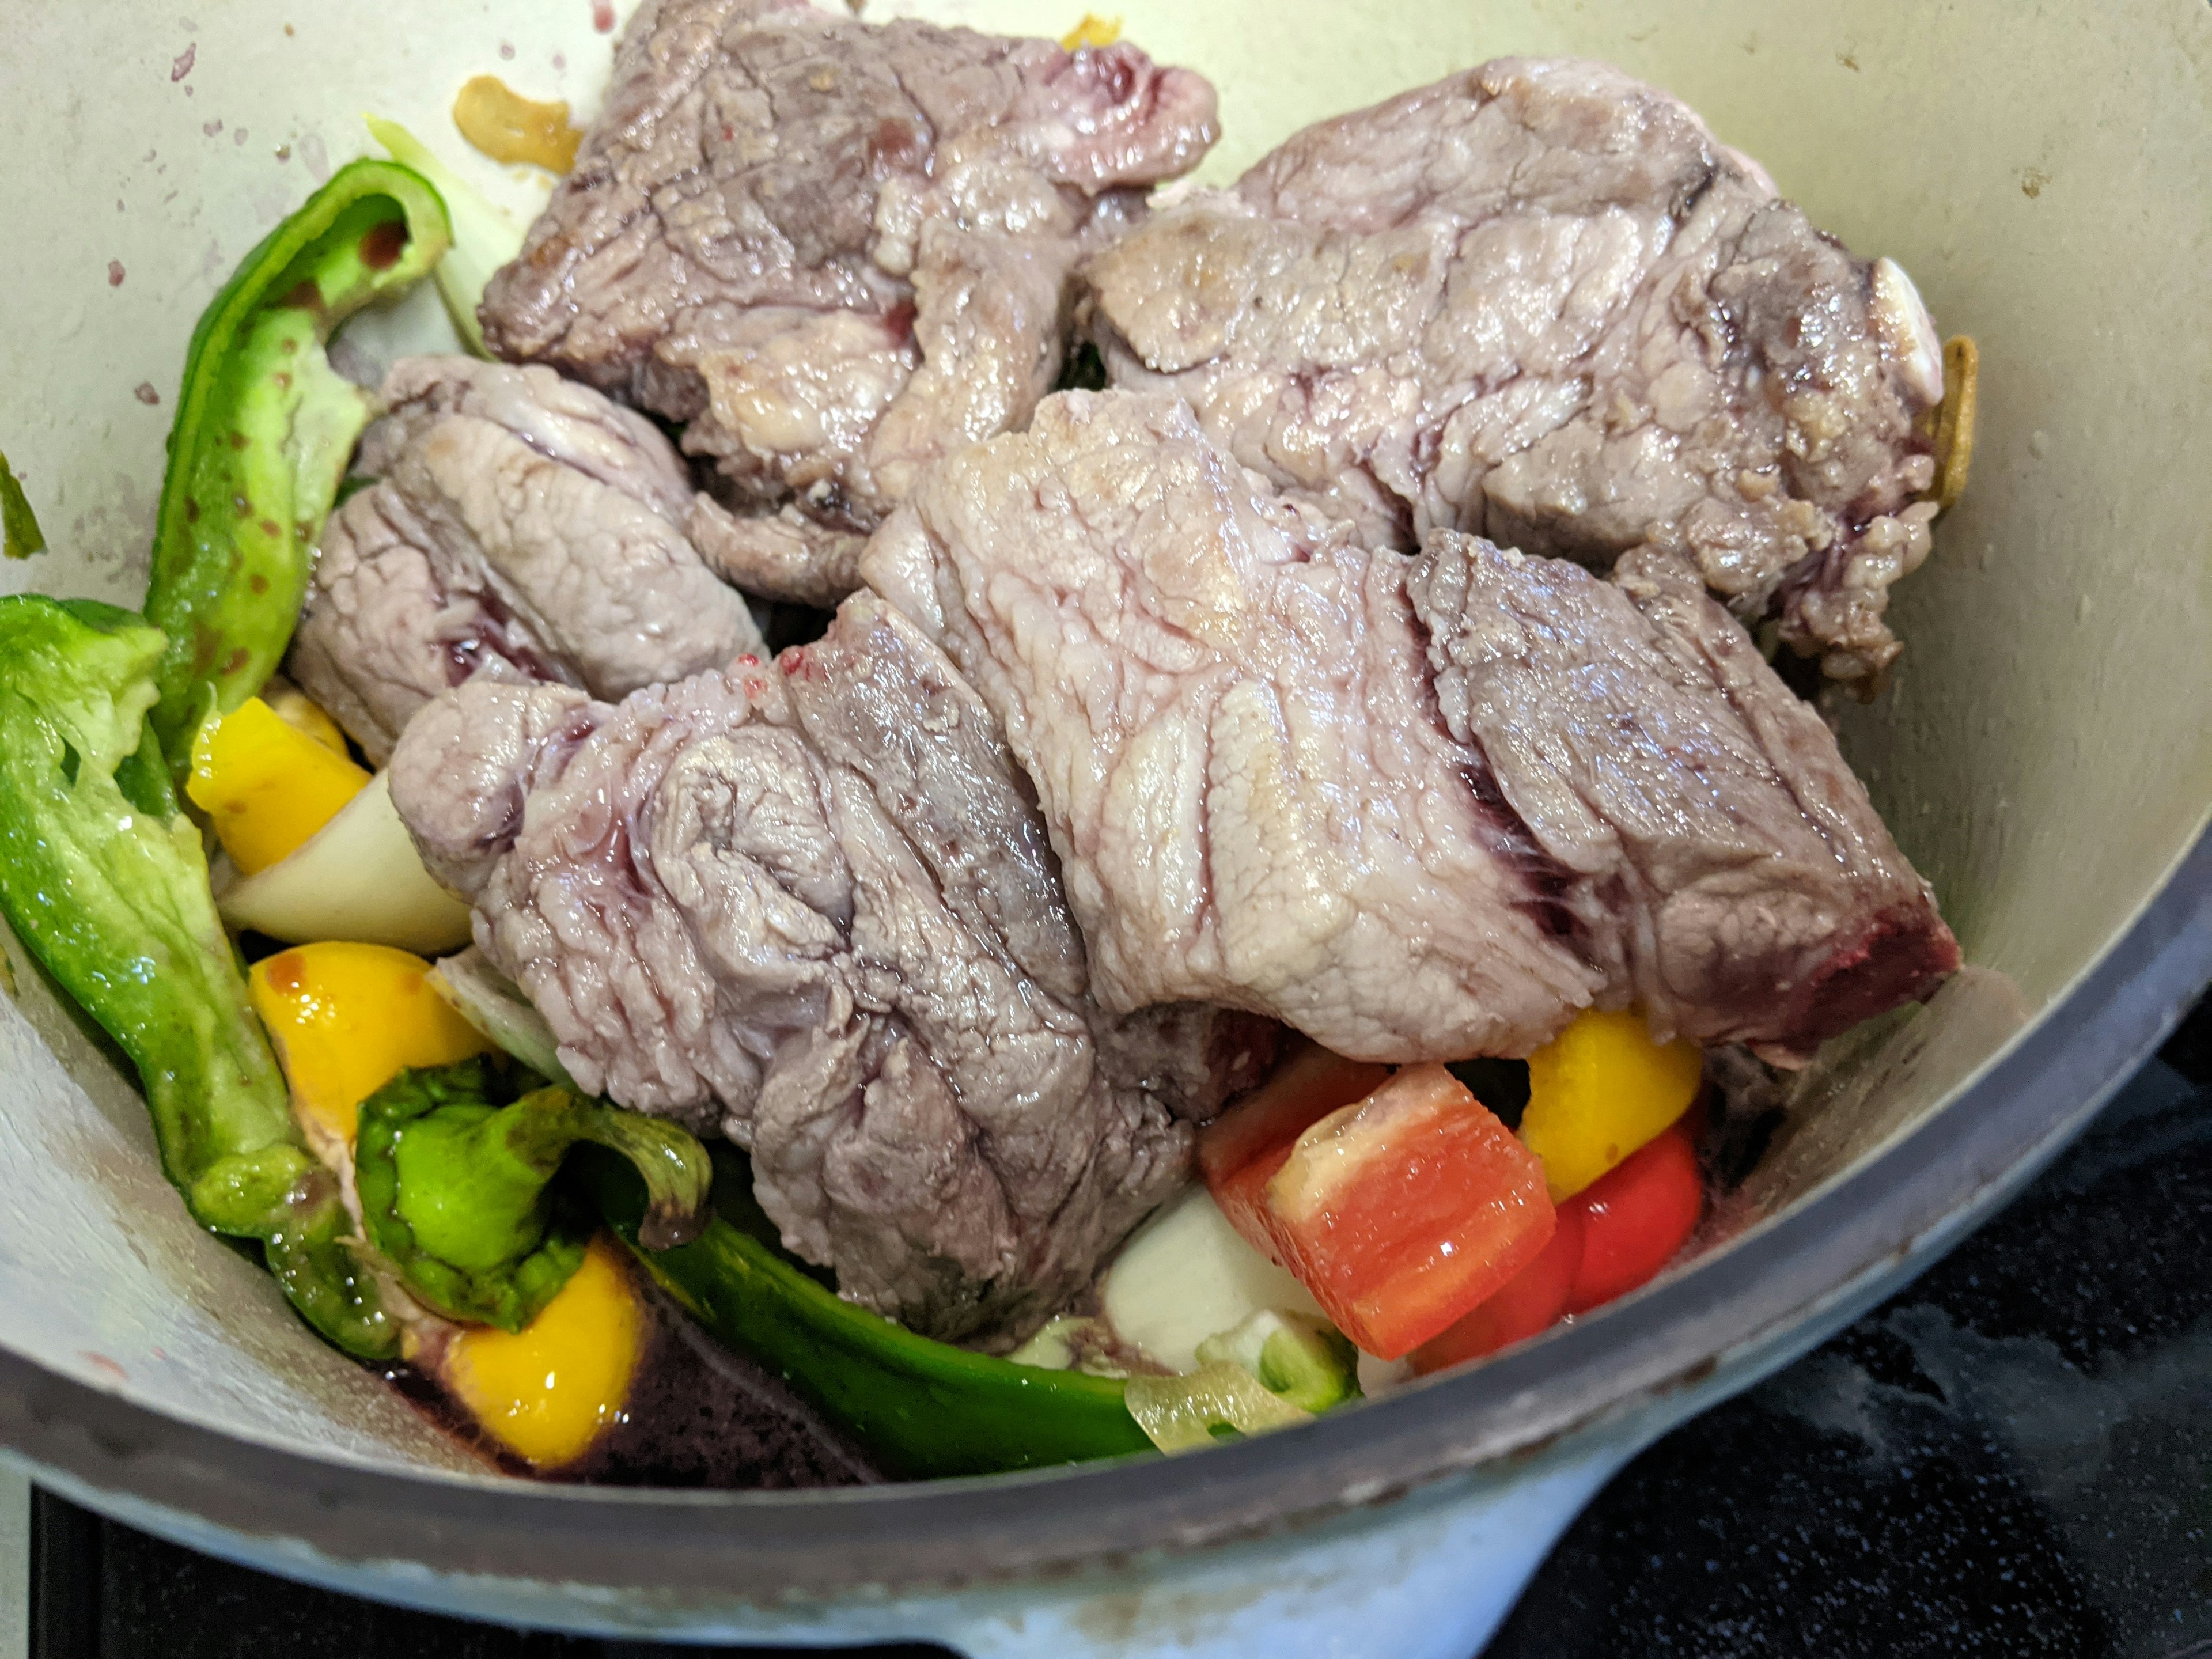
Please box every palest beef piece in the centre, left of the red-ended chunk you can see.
[867,392,1599,1059]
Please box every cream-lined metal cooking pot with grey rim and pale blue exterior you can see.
[0,0,2212,1654]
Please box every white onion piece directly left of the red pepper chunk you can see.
[1099,1185,1320,1372]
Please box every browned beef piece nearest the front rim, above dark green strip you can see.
[392,595,1272,1343]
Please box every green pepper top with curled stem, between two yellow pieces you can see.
[354,1066,710,1332]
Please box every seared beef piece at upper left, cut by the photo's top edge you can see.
[482,0,1217,604]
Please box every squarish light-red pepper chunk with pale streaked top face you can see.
[1263,1064,1553,1361]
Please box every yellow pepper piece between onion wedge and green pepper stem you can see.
[248,940,491,1148]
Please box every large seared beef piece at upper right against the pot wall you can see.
[1086,60,1942,684]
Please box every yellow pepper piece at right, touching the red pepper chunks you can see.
[1520,1009,1706,1203]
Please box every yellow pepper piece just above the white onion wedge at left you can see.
[184,697,369,876]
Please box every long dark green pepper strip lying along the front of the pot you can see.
[577,1146,1153,1480]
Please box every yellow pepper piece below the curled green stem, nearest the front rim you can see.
[438,1234,646,1469]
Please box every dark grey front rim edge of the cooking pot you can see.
[0,830,2212,1604]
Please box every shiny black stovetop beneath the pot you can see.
[31,1004,2212,1659]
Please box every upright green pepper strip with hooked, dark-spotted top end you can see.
[146,161,453,770]
